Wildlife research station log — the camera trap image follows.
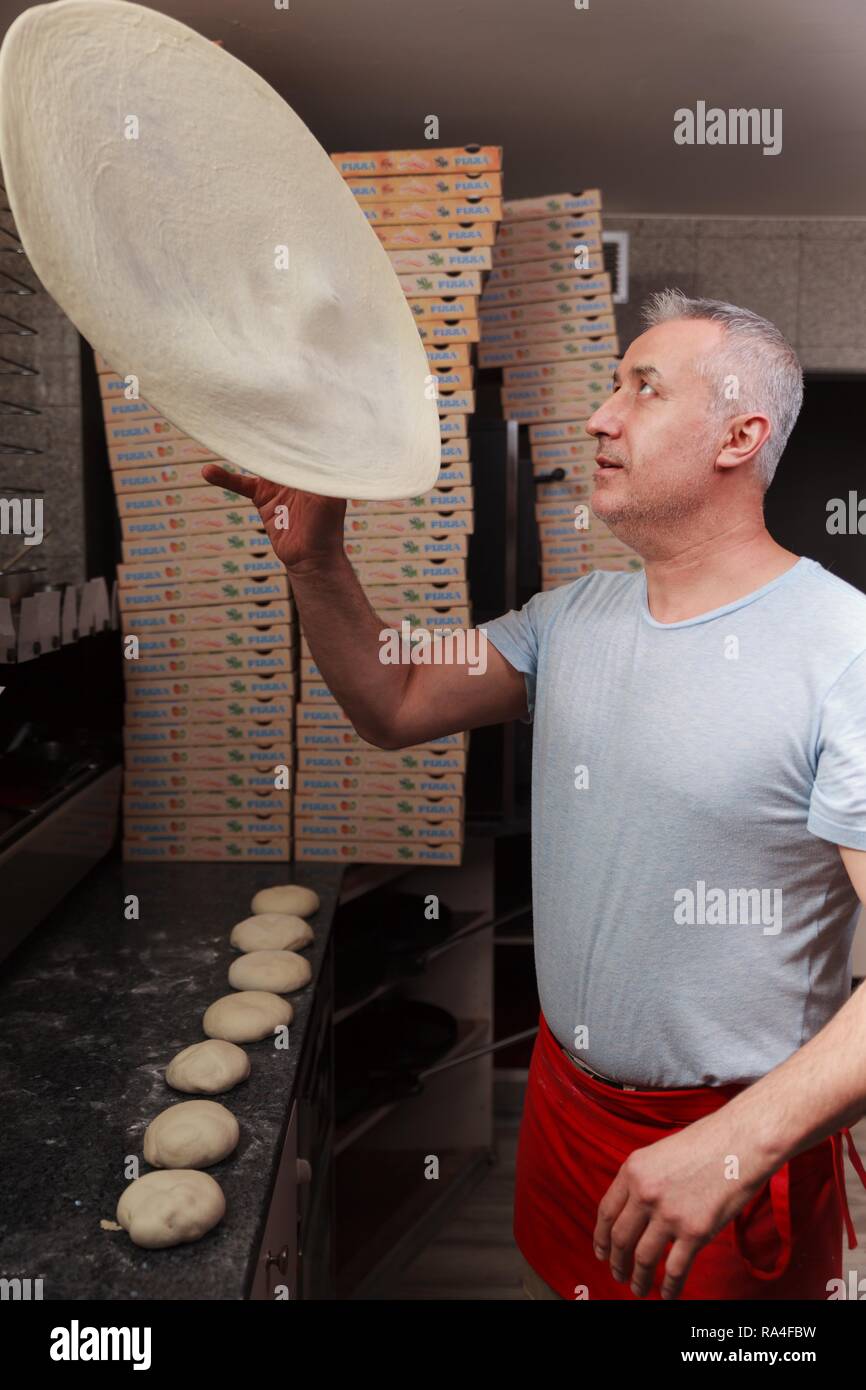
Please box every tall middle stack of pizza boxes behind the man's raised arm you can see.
[295,146,502,865]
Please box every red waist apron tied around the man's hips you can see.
[514,1015,866,1300]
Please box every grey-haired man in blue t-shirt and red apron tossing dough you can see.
[206,292,866,1298]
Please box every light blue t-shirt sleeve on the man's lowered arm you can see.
[806,652,866,849]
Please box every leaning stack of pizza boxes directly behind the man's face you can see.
[480,189,642,589]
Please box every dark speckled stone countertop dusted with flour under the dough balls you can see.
[0,858,342,1300]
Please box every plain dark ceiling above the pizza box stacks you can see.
[0,0,866,217]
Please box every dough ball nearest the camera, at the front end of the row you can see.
[115,1168,225,1250]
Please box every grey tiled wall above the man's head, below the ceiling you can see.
[605,213,866,371]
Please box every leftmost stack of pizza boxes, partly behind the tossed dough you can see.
[96,354,296,863]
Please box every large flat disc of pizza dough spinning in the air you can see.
[0,0,441,498]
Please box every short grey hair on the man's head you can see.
[644,289,803,488]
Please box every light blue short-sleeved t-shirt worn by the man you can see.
[487,559,866,1087]
